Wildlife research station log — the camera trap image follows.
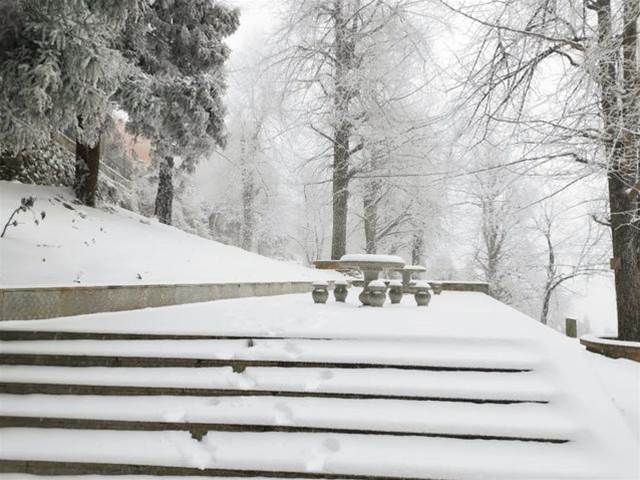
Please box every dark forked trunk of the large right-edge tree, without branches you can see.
[597,0,640,341]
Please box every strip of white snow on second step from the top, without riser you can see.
[0,365,558,402]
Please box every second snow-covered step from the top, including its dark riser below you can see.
[0,365,557,403]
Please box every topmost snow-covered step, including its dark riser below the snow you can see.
[0,338,539,372]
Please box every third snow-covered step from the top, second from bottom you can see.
[0,395,579,442]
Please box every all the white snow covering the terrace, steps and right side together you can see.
[0,289,640,480]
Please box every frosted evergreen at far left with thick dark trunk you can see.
[0,0,147,205]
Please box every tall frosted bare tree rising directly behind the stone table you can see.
[276,0,432,259]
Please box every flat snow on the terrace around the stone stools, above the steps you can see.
[0,288,544,342]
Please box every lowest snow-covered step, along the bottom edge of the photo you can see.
[0,428,629,480]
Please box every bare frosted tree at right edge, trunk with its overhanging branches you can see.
[441,0,640,341]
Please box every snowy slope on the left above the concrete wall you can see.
[0,182,328,287]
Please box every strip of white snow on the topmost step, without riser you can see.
[0,340,538,370]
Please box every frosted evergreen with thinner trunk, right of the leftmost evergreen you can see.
[119,0,239,224]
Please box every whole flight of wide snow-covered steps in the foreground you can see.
[0,292,636,480]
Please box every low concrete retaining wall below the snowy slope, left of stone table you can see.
[0,282,311,320]
